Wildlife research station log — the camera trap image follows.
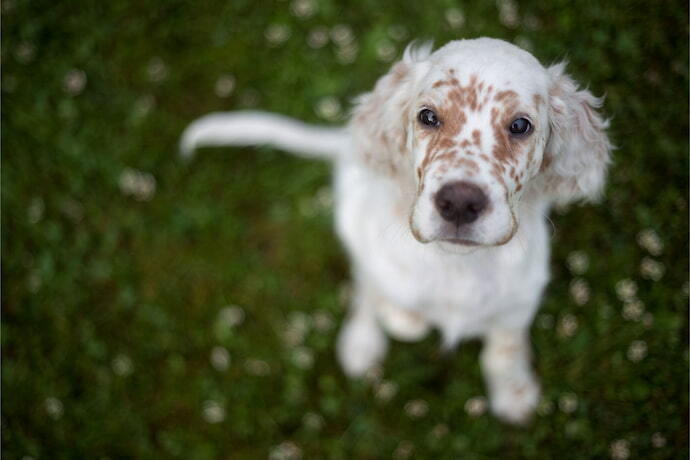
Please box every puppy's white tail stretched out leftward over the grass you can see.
[180,111,348,158]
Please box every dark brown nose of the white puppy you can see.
[434,181,488,225]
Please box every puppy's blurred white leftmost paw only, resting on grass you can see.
[337,317,387,377]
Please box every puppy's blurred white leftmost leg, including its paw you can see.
[337,282,388,377]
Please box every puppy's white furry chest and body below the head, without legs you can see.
[336,162,548,336]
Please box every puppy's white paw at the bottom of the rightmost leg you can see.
[491,378,541,425]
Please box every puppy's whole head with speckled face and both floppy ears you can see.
[352,38,611,246]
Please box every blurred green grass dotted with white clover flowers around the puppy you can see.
[1,0,688,459]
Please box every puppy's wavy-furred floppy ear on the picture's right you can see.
[541,63,612,204]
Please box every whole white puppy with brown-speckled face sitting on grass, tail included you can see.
[182,38,611,422]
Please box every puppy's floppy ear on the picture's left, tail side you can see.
[350,42,432,177]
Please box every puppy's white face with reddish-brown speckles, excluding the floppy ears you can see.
[408,42,549,246]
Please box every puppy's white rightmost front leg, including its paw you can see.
[481,329,540,423]
